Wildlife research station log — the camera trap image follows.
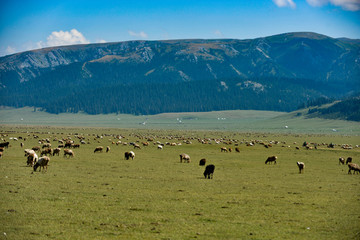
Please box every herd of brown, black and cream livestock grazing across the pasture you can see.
[0,134,360,179]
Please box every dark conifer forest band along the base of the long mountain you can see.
[0,72,338,115]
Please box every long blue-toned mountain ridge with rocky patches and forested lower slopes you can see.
[0,33,360,114]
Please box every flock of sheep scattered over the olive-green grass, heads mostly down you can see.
[0,135,360,179]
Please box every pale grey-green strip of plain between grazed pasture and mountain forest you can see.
[0,108,360,135]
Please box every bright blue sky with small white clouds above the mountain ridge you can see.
[0,0,360,56]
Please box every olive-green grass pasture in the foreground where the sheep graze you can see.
[0,126,360,240]
